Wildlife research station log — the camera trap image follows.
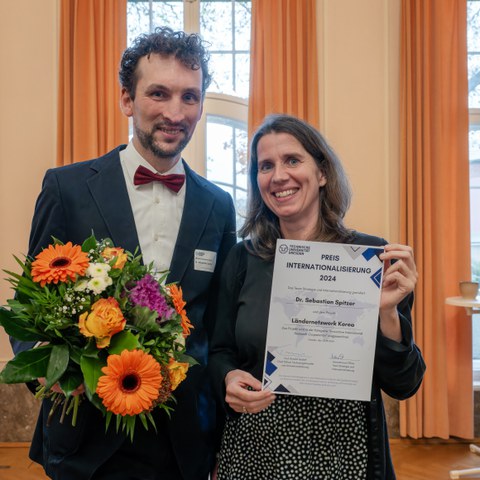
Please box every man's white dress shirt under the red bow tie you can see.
[120,142,186,272]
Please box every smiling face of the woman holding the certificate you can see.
[257,133,327,233]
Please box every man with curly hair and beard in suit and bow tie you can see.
[13,28,236,480]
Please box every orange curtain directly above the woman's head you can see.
[248,0,319,133]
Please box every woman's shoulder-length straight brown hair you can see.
[239,114,352,260]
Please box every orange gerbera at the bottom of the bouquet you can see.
[97,350,163,416]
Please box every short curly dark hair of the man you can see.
[118,27,212,100]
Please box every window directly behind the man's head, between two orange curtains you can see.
[127,0,251,227]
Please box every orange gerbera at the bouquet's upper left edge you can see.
[32,242,89,287]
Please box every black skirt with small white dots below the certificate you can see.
[218,395,368,480]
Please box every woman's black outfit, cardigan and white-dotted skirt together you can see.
[209,234,425,480]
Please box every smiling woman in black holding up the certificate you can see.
[210,115,425,480]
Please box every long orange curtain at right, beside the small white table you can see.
[400,0,473,438]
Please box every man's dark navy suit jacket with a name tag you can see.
[12,145,236,480]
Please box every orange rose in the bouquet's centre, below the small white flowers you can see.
[78,297,126,348]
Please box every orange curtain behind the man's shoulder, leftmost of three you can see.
[57,0,128,165]
